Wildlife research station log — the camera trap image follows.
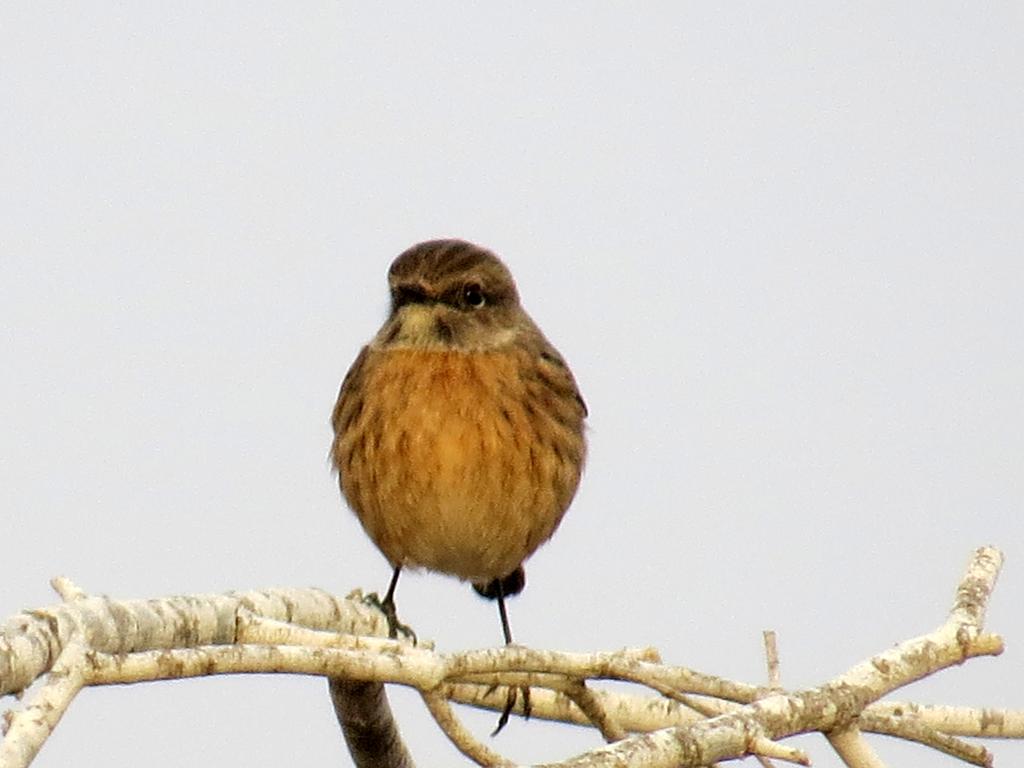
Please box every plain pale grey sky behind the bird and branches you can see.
[0,2,1024,768]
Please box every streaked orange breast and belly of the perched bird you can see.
[333,348,584,582]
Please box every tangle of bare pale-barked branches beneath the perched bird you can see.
[0,548,1024,768]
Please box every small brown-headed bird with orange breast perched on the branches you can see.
[331,240,587,729]
